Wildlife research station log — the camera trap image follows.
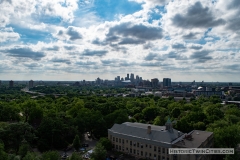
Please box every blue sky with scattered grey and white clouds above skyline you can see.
[0,0,240,82]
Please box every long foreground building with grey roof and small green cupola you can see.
[108,120,213,160]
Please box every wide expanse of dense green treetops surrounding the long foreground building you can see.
[0,86,240,159]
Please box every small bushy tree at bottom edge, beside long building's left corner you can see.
[91,143,107,160]
